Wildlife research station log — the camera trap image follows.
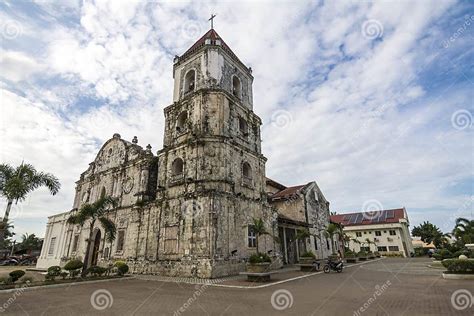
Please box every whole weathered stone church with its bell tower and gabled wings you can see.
[37,28,339,278]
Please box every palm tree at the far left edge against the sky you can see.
[0,163,61,242]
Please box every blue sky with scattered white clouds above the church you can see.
[0,0,474,241]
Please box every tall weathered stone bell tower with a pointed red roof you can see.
[157,29,277,277]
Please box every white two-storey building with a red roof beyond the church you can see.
[331,208,414,257]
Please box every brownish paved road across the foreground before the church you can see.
[0,259,474,316]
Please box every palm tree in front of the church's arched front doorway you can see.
[67,197,117,275]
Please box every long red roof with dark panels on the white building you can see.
[331,208,406,226]
